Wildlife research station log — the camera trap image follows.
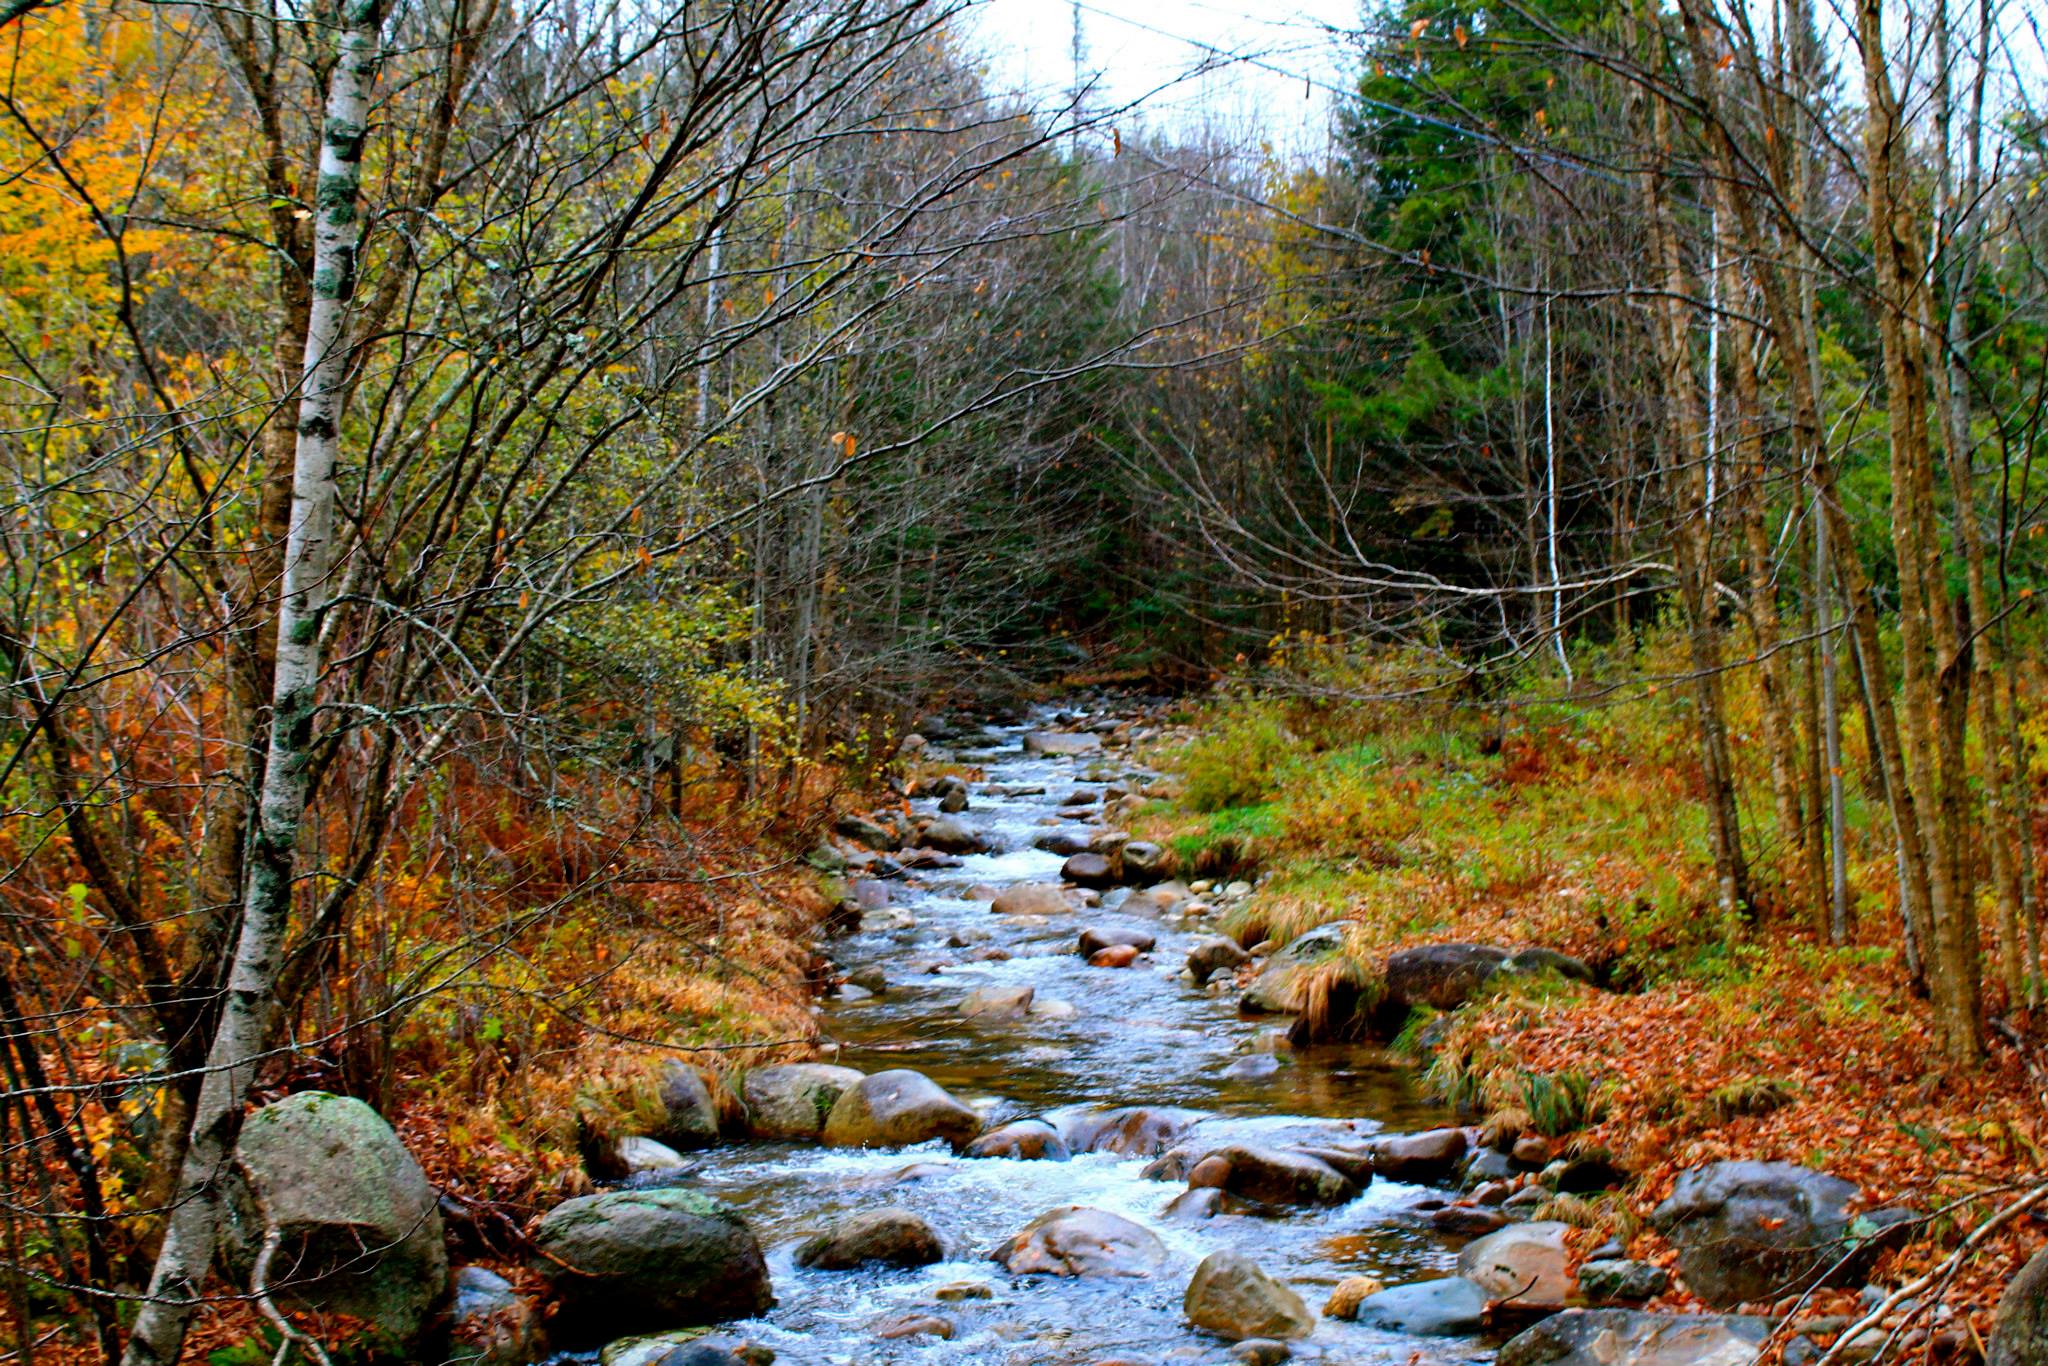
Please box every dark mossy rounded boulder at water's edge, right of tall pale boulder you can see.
[532,1186,774,1337]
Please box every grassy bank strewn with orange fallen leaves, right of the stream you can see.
[1133,655,2048,1360]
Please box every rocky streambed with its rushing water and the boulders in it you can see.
[528,713,1523,1366]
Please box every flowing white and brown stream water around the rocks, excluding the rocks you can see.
[606,715,1491,1366]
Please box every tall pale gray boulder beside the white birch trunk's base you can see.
[221,1092,449,1343]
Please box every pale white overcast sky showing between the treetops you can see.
[969,0,1360,150]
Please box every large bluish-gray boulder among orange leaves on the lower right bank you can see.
[1651,1161,1882,1309]
